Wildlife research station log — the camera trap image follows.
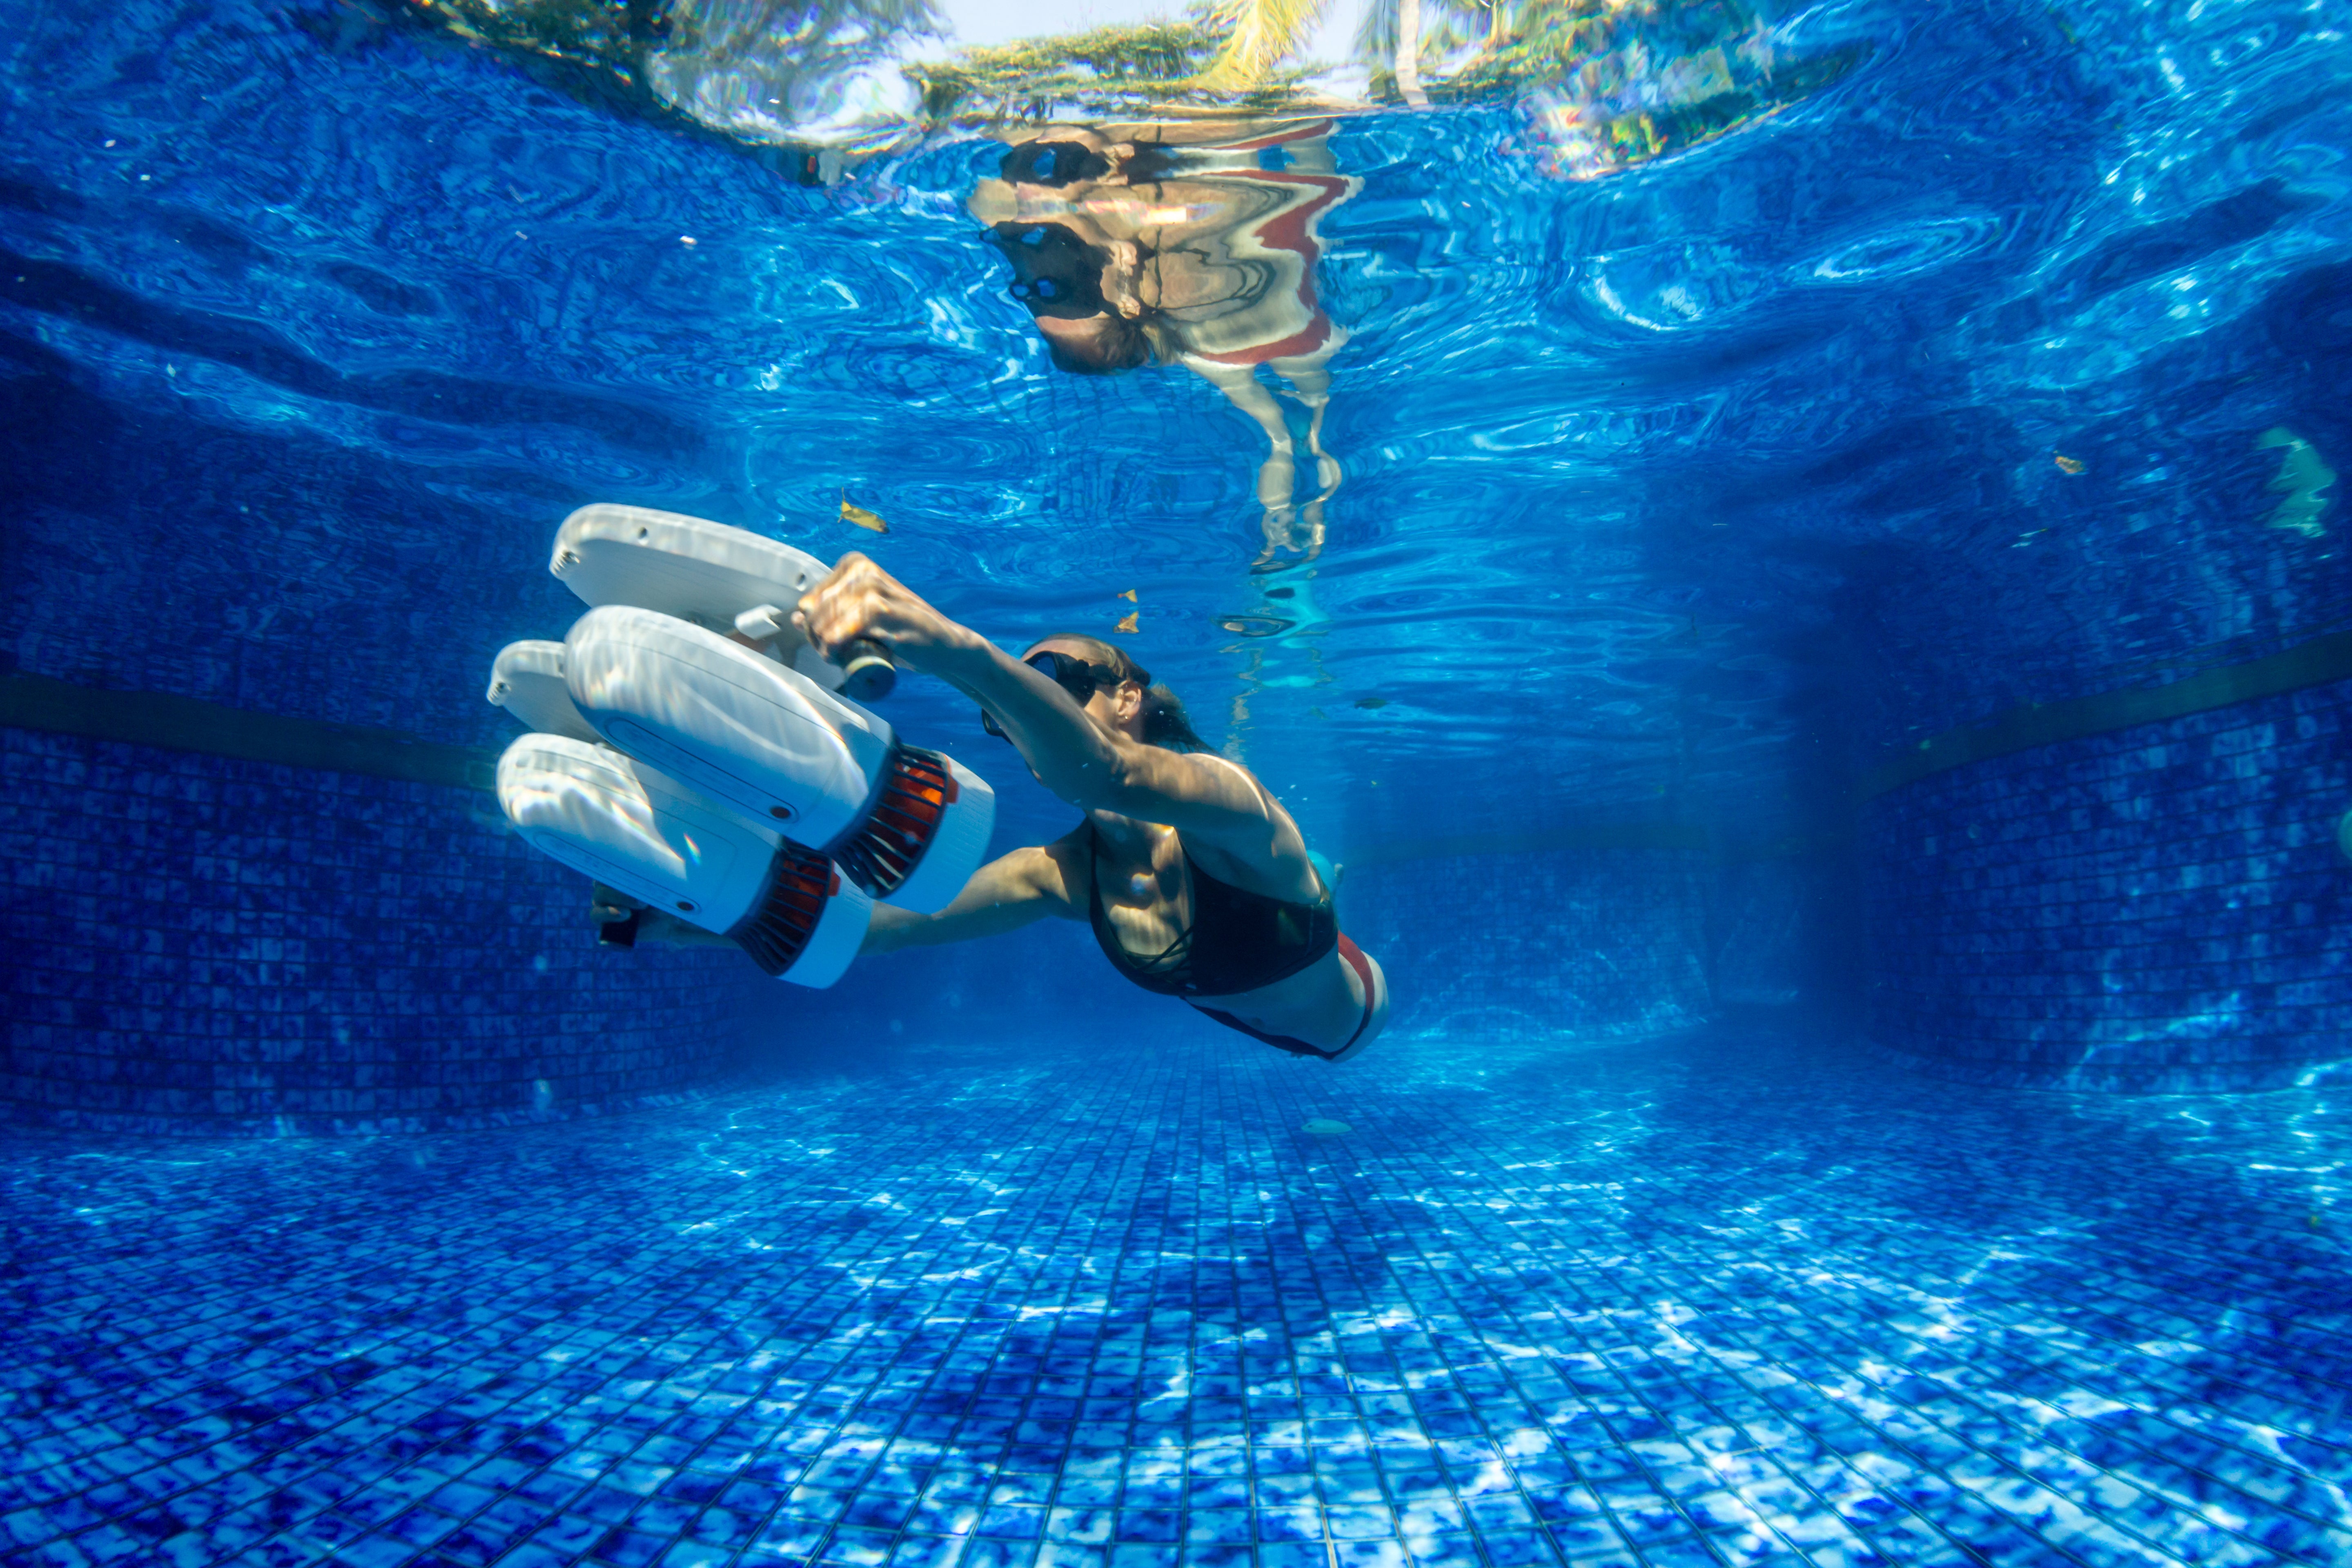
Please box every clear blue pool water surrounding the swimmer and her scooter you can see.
[0,0,2352,1568]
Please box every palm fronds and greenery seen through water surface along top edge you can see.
[404,0,1863,143]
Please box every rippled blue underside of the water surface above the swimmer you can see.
[0,2,2352,842]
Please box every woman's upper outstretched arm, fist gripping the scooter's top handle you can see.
[793,550,1303,860]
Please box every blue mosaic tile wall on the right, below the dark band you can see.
[1863,682,2352,1091]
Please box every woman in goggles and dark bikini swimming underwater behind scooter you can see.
[604,552,1388,1062]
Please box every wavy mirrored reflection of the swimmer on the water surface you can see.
[971,120,1359,557]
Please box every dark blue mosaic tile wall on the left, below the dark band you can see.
[0,729,760,1133]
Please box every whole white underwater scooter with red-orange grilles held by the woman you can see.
[489,506,995,987]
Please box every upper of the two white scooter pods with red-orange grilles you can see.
[564,604,997,915]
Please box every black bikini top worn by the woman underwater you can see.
[1087,823,1338,997]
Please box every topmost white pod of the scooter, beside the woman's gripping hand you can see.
[548,501,849,691]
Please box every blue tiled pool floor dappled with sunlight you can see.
[0,1030,2352,1568]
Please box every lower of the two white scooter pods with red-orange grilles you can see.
[499,733,873,987]
